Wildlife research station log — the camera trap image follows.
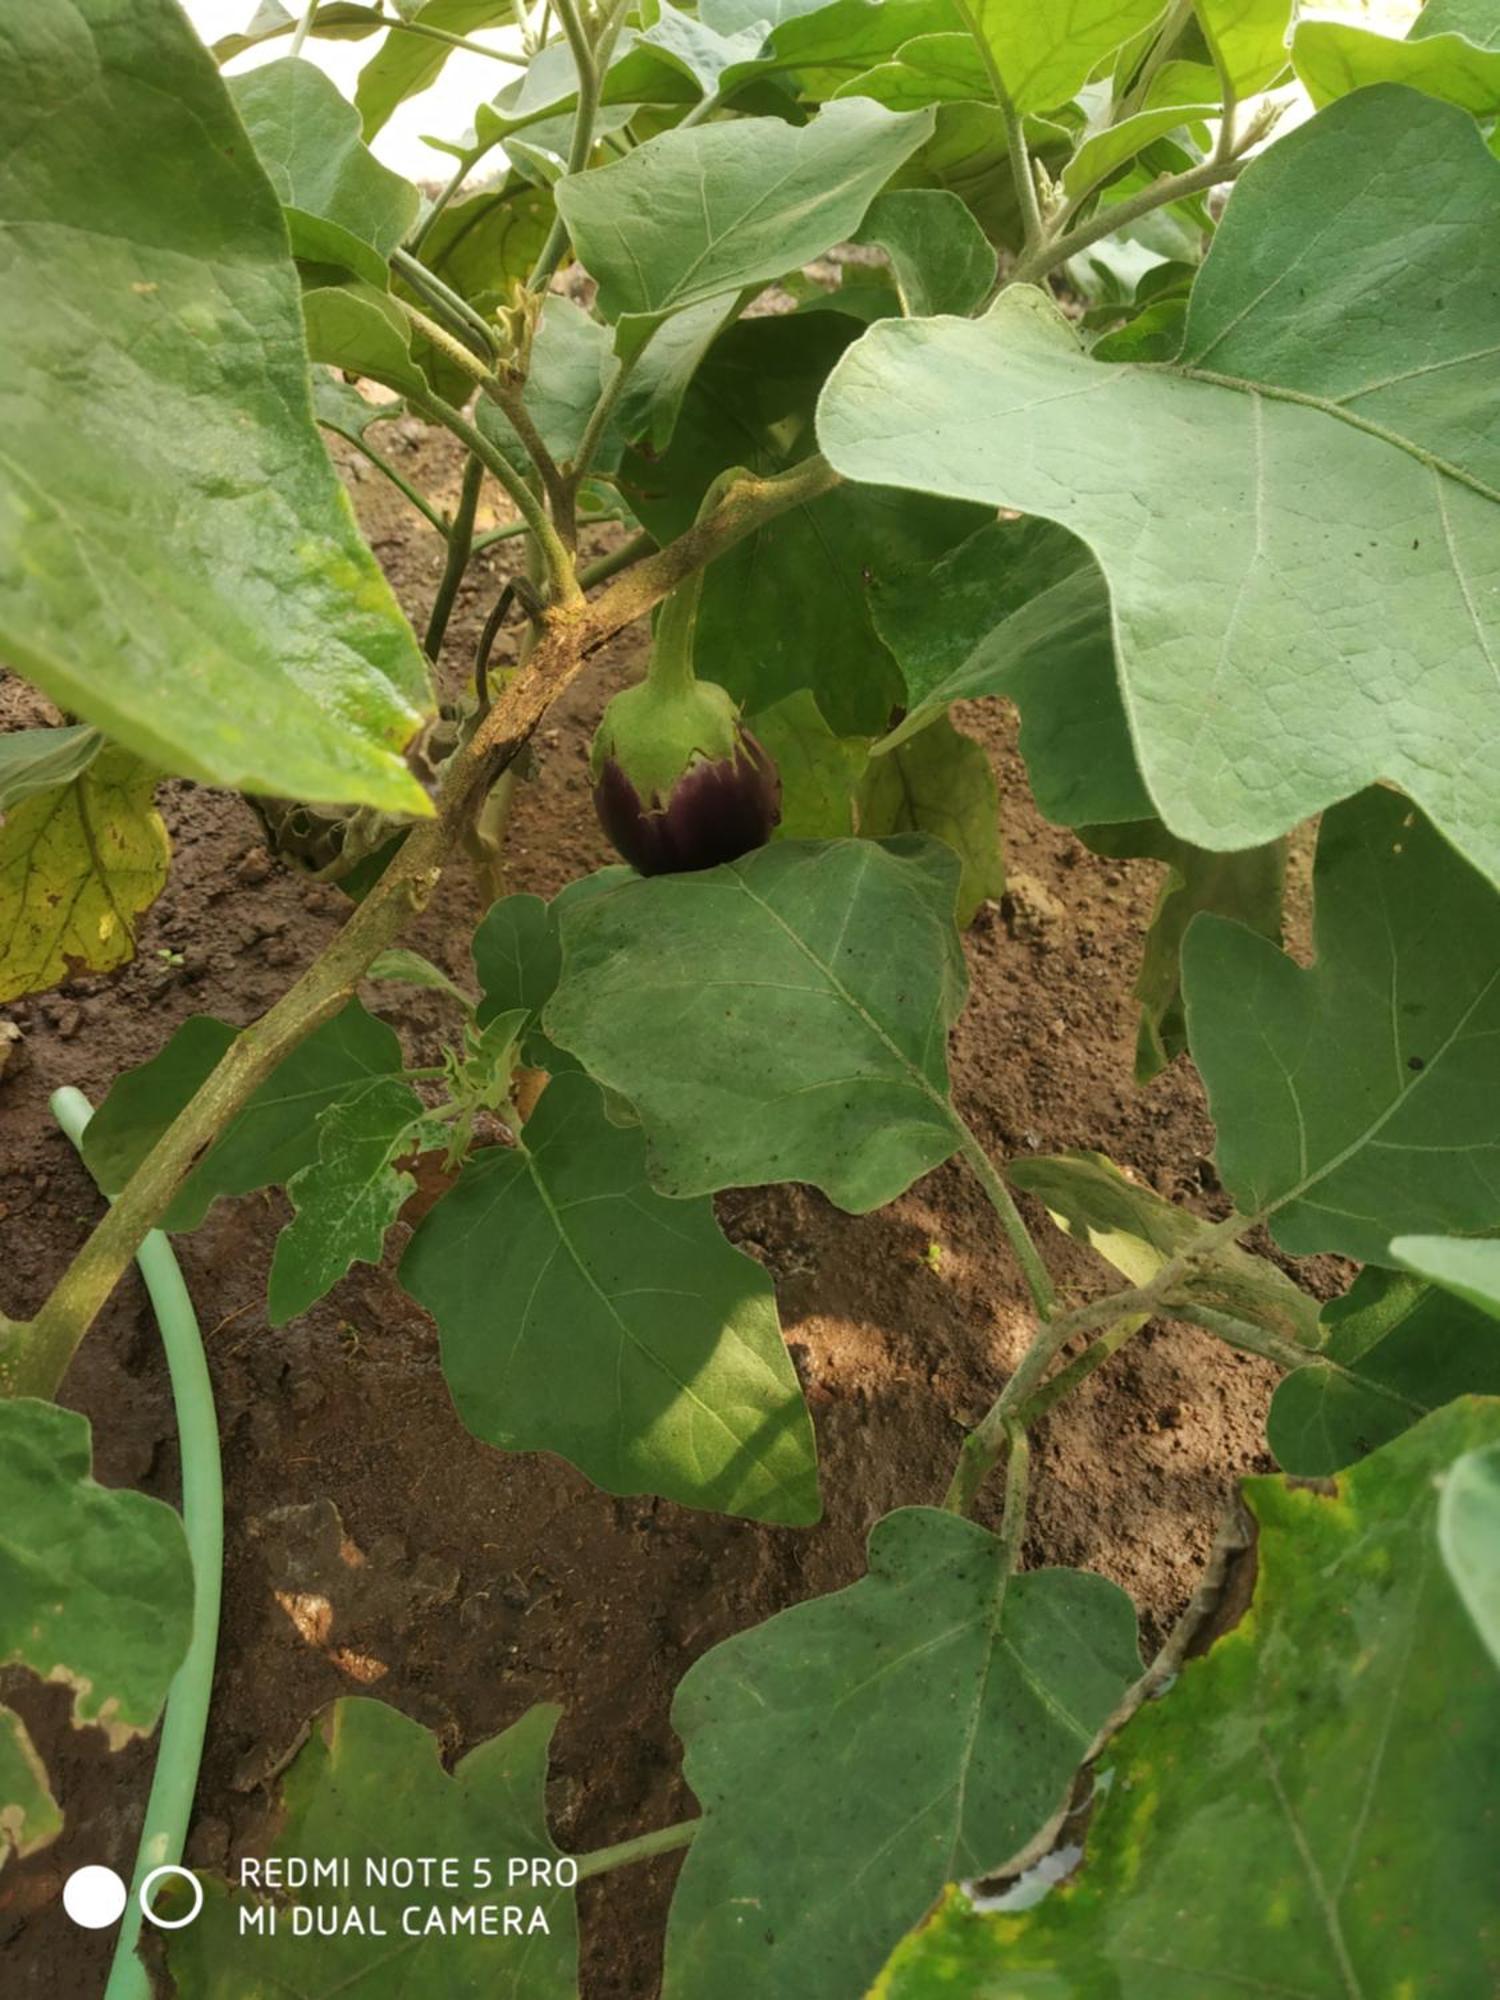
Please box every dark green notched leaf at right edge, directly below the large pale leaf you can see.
[1182,790,1500,1264]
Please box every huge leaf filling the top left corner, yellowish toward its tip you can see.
[0,0,432,812]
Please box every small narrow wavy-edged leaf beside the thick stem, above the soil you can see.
[268,1076,422,1326]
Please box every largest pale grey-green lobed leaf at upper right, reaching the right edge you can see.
[818,88,1500,876]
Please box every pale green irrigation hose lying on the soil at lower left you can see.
[52,1086,224,2000]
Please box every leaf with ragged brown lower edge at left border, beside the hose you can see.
[0,1396,192,1750]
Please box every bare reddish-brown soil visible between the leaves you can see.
[0,426,1336,2000]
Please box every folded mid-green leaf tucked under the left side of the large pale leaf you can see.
[870,520,1150,826]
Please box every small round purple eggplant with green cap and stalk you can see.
[590,586,782,874]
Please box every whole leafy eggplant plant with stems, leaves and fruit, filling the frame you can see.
[0,0,1500,2000]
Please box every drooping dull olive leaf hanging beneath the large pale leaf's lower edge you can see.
[1082,820,1286,1084]
